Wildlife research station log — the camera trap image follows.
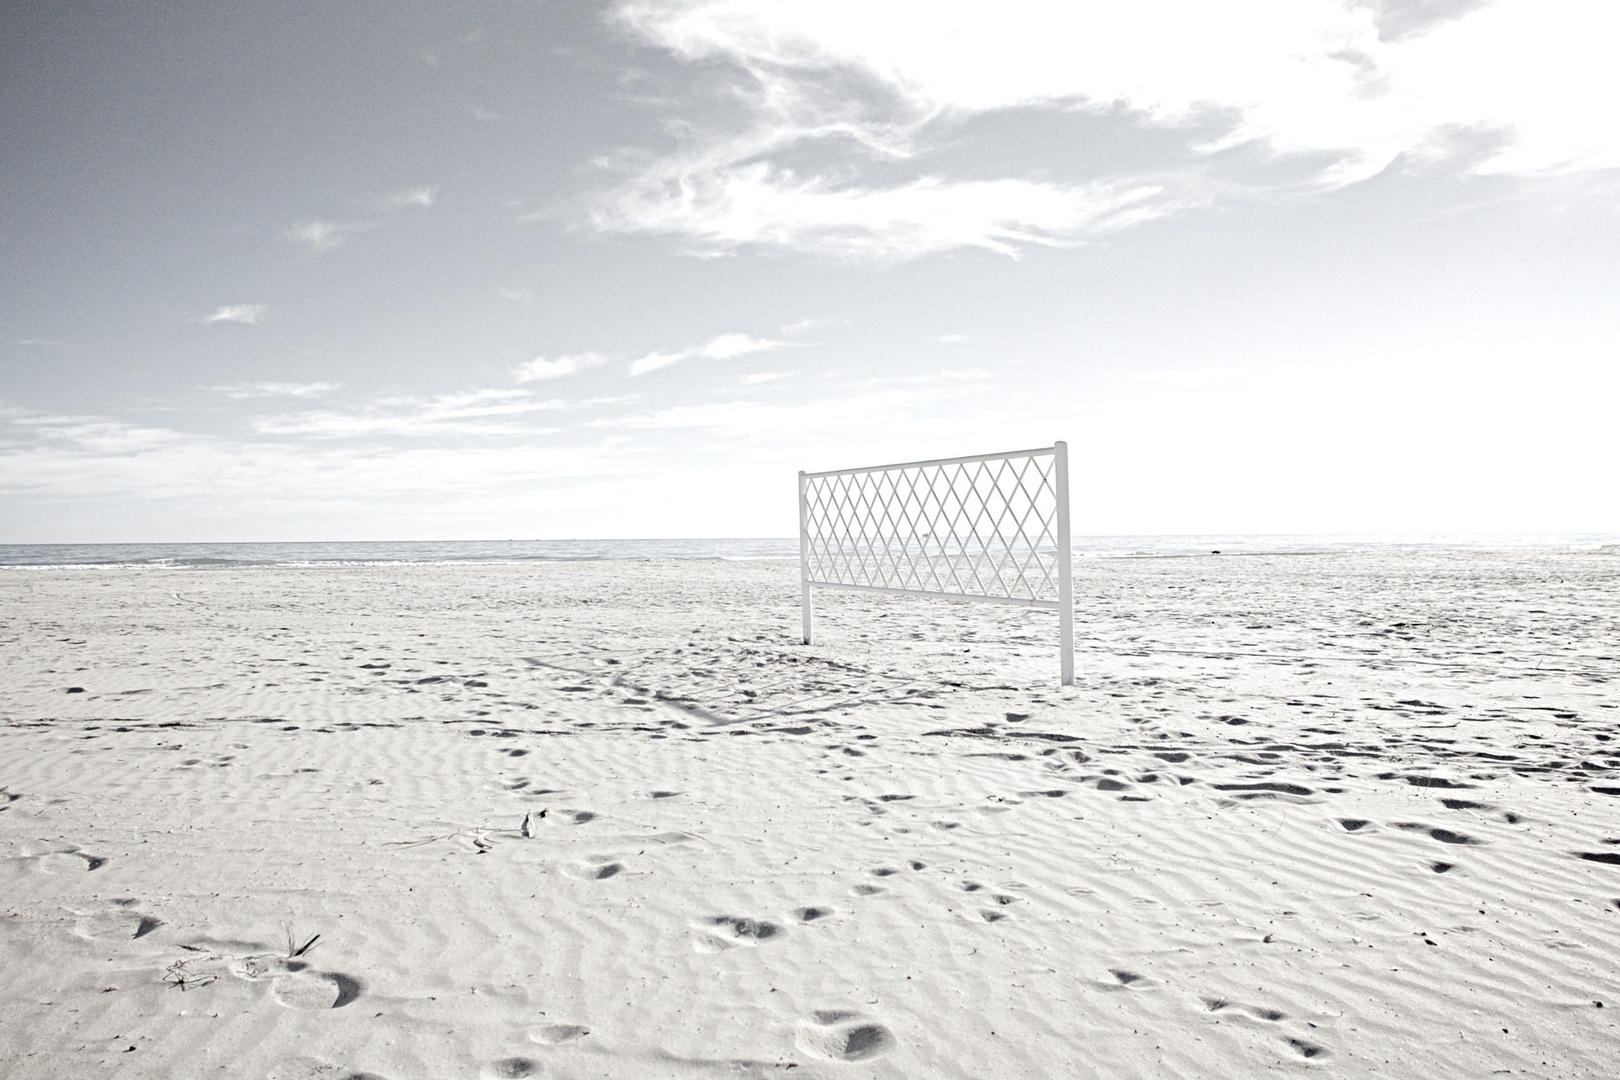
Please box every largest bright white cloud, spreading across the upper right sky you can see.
[605,0,1620,261]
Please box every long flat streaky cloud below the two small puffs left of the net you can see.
[253,389,570,439]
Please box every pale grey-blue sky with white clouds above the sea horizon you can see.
[0,0,1620,542]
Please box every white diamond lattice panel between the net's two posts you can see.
[805,452,1058,604]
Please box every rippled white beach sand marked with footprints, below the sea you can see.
[0,554,1620,1080]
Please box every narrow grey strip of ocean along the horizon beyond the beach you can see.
[0,533,1620,570]
